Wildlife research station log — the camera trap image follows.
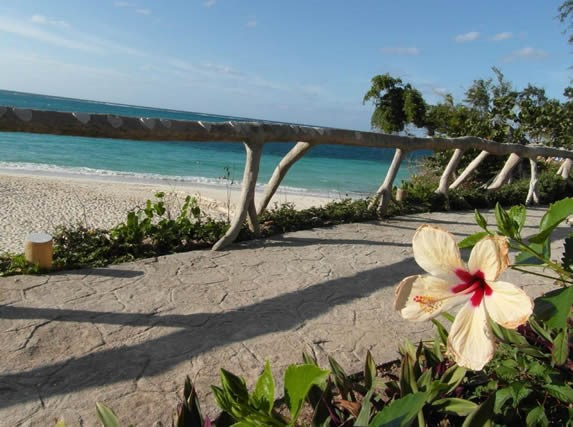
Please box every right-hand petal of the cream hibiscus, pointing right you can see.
[484,282,533,329]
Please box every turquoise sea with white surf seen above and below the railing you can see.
[0,90,420,195]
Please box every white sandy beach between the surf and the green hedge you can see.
[0,171,332,253]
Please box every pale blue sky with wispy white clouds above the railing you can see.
[0,0,573,130]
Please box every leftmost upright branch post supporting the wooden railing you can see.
[212,140,263,251]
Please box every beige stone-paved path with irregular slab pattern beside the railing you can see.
[0,209,566,426]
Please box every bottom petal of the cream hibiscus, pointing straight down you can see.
[448,304,495,371]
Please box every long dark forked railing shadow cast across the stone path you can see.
[0,258,419,409]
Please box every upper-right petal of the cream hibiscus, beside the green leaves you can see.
[468,236,509,281]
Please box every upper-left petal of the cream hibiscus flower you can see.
[412,224,465,281]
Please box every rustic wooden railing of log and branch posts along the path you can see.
[0,107,573,250]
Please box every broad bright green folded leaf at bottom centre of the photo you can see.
[284,365,330,425]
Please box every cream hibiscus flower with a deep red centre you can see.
[394,225,533,370]
